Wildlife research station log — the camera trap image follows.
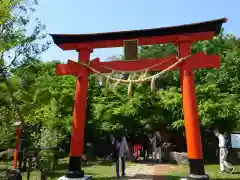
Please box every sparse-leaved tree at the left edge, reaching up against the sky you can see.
[0,0,50,149]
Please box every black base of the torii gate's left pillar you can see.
[66,156,84,179]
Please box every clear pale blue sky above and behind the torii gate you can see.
[34,0,240,61]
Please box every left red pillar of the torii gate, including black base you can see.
[66,45,93,178]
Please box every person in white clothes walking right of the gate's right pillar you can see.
[214,130,234,173]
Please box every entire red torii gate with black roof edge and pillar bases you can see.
[51,18,227,179]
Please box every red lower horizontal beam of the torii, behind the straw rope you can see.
[56,52,220,76]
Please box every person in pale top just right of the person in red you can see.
[151,132,162,163]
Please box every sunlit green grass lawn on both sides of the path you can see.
[0,160,240,180]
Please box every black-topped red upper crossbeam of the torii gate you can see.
[51,18,227,50]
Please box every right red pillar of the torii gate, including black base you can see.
[177,41,209,180]
